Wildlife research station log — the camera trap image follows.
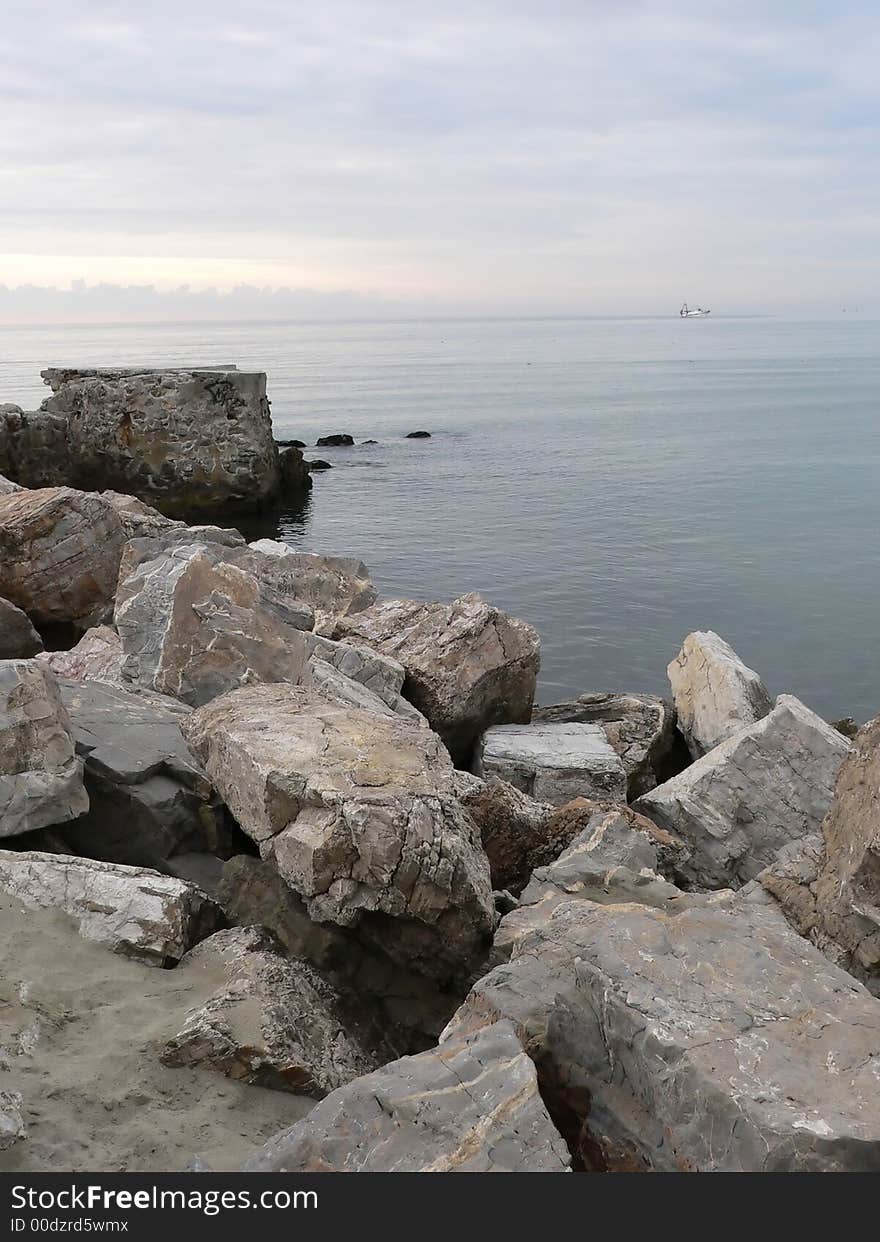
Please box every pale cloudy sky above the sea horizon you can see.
[0,0,880,323]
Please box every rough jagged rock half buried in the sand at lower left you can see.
[161,928,381,1095]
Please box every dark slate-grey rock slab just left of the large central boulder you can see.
[61,682,227,872]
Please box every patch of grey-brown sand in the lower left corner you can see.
[0,895,313,1172]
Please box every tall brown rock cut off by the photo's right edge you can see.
[815,717,880,990]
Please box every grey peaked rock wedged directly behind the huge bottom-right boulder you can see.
[492,799,700,964]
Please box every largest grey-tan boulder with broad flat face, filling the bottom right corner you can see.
[441,899,880,1172]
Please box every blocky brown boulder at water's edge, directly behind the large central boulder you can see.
[338,595,540,768]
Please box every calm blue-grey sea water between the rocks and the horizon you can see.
[0,314,880,719]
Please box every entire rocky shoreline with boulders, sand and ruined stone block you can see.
[0,368,880,1172]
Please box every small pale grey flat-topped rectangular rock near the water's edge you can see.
[474,724,627,806]
